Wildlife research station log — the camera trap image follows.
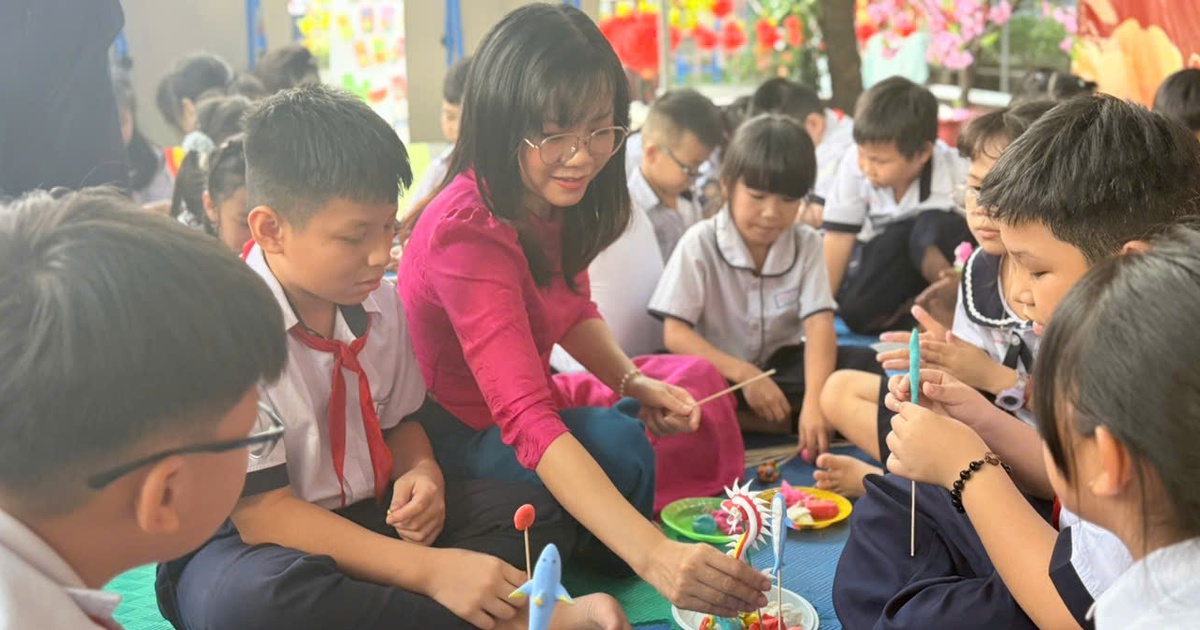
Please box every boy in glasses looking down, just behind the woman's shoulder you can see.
[628,89,722,259]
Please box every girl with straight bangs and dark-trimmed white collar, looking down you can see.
[650,114,883,458]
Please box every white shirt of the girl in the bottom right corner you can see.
[1093,538,1200,630]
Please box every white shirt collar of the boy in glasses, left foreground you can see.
[0,510,121,628]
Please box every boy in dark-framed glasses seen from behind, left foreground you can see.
[0,188,287,630]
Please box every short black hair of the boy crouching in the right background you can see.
[854,77,937,158]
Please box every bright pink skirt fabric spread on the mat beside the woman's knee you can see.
[554,354,746,514]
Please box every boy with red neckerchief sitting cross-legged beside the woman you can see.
[158,85,604,630]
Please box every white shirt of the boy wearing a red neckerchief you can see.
[244,245,425,509]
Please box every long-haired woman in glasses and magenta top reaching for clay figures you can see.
[398,4,769,617]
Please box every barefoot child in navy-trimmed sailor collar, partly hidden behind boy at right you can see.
[815,101,1054,497]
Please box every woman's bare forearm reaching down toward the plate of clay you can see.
[536,433,665,576]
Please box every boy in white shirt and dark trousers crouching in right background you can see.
[823,77,971,335]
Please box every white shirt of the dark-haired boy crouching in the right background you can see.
[824,140,970,242]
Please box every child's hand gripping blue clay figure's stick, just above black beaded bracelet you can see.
[887,402,988,490]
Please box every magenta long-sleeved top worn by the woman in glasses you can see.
[397,173,600,469]
